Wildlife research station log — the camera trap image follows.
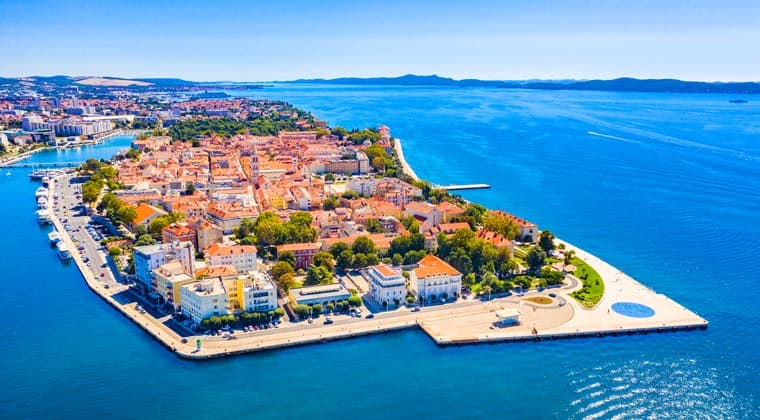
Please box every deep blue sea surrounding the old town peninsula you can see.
[0,85,760,419]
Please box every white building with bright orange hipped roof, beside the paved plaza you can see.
[409,254,462,302]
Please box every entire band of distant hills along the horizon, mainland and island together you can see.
[0,74,760,94]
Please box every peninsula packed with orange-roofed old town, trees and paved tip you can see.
[14,93,707,359]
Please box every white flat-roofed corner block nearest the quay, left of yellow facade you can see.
[179,278,229,324]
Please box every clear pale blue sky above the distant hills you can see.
[0,0,760,81]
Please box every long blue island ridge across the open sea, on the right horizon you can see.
[289,74,760,94]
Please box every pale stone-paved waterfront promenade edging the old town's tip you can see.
[41,166,708,360]
